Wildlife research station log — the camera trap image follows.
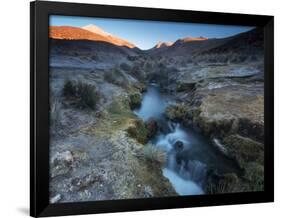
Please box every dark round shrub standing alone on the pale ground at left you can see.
[63,81,100,109]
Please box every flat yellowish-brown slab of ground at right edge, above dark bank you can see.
[191,83,264,138]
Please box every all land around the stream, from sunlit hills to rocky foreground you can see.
[50,26,264,203]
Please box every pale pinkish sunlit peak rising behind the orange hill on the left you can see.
[82,24,136,48]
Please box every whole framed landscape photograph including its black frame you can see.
[30,1,274,217]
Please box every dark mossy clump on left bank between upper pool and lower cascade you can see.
[127,120,148,144]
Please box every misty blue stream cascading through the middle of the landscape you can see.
[134,84,237,195]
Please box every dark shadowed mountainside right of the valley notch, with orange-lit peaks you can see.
[146,28,263,60]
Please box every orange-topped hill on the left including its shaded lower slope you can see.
[49,26,140,69]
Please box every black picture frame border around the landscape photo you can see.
[30,1,274,217]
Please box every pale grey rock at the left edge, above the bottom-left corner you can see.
[51,151,74,177]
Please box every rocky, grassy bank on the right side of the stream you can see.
[161,63,264,193]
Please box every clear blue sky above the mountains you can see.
[50,15,254,50]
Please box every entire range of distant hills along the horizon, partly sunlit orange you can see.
[49,25,263,63]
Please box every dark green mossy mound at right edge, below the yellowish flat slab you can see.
[223,135,264,168]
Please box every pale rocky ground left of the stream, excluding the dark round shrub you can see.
[50,63,176,203]
